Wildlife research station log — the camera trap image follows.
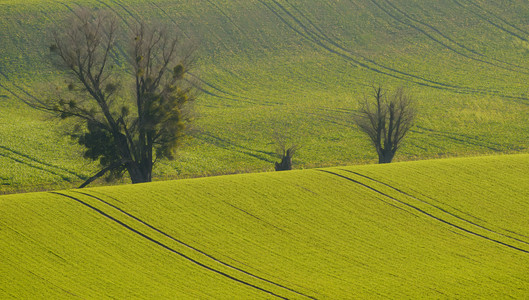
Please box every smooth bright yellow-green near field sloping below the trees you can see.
[0,155,529,299]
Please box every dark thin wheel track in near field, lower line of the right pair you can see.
[318,170,529,254]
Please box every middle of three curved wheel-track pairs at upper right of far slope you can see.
[372,0,529,74]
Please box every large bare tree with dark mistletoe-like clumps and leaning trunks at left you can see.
[42,9,195,187]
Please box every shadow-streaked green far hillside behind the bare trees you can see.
[0,0,529,191]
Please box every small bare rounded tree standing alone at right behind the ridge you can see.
[354,86,417,164]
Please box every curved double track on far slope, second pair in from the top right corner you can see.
[384,0,529,75]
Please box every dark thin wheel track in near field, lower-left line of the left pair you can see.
[50,192,294,299]
